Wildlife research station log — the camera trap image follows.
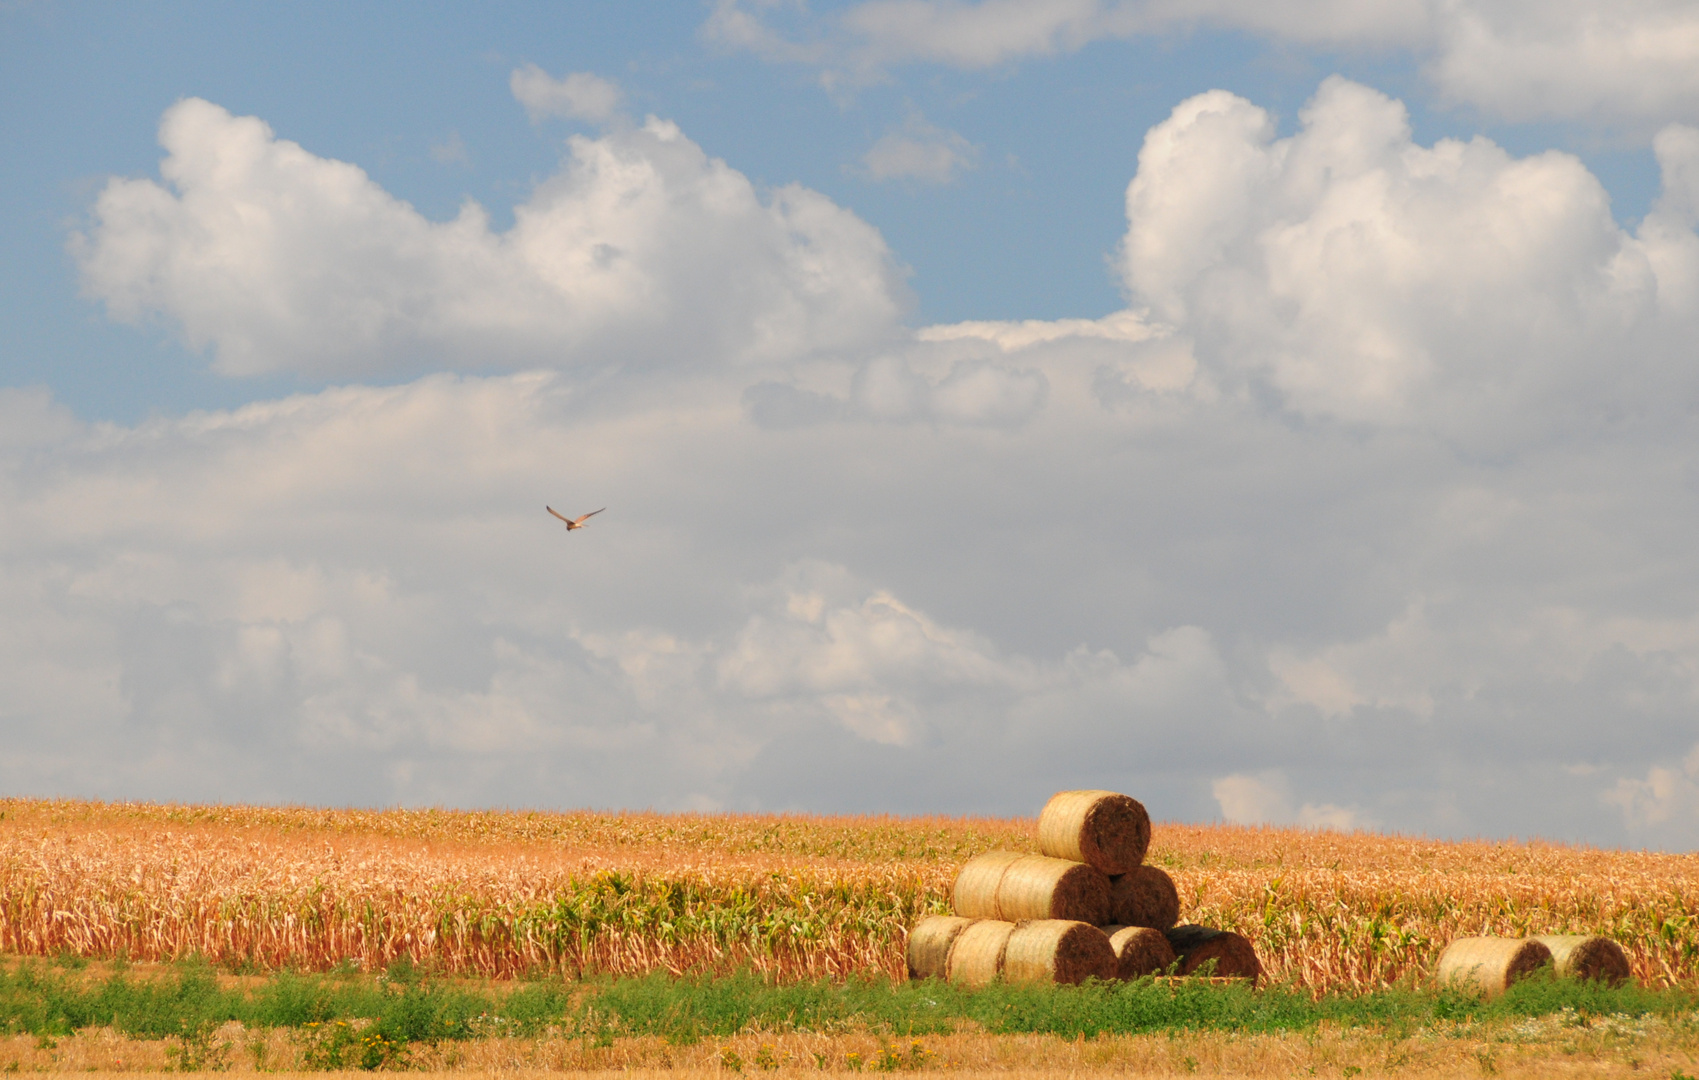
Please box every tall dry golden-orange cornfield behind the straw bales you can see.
[0,800,1699,992]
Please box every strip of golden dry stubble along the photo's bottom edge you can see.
[0,1017,1699,1080]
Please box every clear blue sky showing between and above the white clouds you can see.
[0,2,1657,421]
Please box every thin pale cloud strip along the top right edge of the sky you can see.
[703,0,1699,127]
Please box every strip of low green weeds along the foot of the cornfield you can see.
[0,961,1699,1065]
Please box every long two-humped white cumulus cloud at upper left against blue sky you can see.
[71,98,904,377]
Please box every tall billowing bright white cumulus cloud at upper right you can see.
[1121,76,1699,442]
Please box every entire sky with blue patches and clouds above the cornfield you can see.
[0,0,1699,851]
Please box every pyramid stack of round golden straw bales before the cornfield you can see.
[909,791,1261,987]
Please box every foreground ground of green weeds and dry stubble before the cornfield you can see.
[0,958,1699,1080]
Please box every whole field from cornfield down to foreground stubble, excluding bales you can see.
[0,800,1699,1078]
